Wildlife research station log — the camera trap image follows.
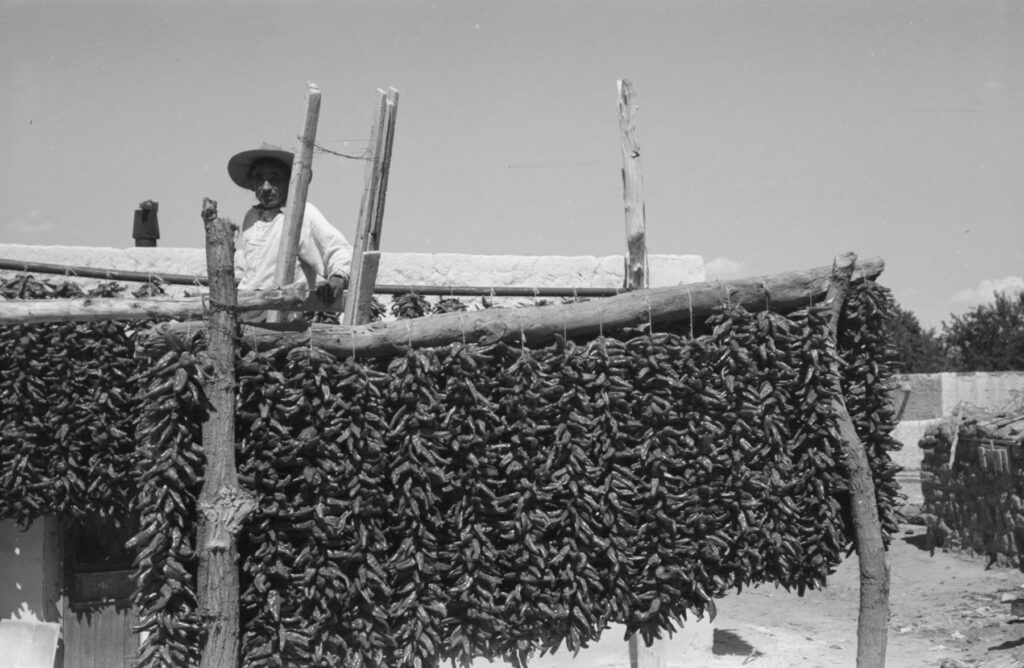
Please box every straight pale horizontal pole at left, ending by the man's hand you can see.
[0,281,319,325]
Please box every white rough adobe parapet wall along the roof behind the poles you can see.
[0,244,705,294]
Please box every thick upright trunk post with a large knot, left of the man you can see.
[197,200,256,668]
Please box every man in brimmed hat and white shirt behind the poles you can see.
[227,144,352,311]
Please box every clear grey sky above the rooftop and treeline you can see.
[0,0,1024,326]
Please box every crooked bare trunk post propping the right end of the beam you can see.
[826,253,889,668]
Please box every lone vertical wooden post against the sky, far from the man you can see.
[618,79,649,290]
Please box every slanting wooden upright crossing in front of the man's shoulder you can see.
[267,83,321,323]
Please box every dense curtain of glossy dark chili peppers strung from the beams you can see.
[0,274,899,668]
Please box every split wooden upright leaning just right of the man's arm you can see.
[342,88,398,325]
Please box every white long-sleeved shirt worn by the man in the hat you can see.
[234,202,352,290]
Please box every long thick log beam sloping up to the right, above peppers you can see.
[144,258,885,357]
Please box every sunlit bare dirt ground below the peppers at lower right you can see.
[704,525,1024,668]
